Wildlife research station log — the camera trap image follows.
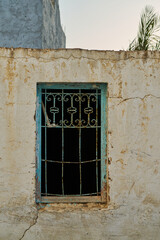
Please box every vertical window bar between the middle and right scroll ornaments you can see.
[79,90,82,195]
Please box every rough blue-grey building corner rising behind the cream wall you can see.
[0,0,65,49]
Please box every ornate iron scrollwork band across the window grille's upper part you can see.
[42,93,98,128]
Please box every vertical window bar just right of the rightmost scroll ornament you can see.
[96,89,98,195]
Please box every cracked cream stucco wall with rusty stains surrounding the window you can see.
[0,49,160,240]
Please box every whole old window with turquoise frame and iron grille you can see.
[36,83,106,203]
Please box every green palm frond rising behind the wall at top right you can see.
[128,6,160,51]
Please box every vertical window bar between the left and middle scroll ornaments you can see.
[62,89,64,195]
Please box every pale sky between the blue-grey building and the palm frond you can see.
[59,0,160,50]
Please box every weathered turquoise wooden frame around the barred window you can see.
[36,83,107,203]
